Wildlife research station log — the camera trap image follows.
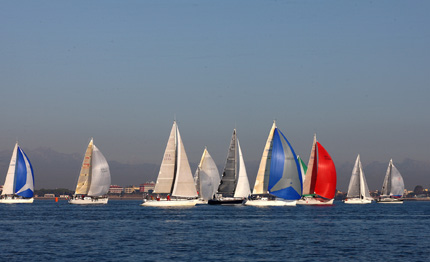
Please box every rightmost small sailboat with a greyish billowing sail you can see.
[376,159,405,204]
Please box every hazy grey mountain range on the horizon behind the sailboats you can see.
[0,147,430,192]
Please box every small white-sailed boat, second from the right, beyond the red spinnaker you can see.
[343,155,373,204]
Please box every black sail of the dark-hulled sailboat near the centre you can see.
[218,129,236,196]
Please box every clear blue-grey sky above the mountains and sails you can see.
[0,0,430,189]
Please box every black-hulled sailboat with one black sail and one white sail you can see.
[208,129,251,205]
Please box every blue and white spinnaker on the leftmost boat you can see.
[15,146,34,197]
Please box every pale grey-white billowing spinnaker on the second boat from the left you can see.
[88,145,111,196]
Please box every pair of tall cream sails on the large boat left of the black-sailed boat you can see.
[154,121,197,197]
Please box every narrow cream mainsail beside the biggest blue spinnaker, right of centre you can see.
[252,122,276,194]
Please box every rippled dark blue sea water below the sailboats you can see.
[0,200,430,261]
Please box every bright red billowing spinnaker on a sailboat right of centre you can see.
[315,142,336,199]
